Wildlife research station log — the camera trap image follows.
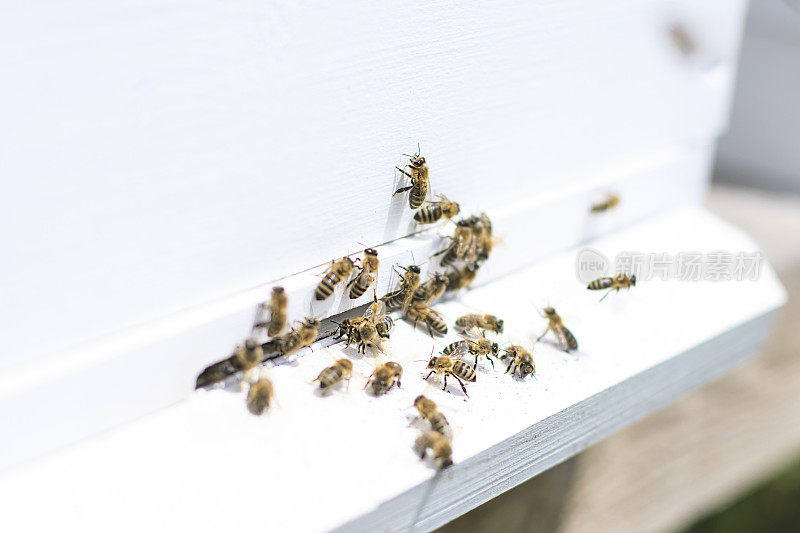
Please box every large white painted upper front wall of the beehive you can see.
[0,0,745,373]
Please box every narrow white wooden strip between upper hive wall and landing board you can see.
[0,145,710,468]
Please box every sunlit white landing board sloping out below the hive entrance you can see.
[0,208,785,531]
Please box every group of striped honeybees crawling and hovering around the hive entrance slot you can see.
[197,148,636,468]
